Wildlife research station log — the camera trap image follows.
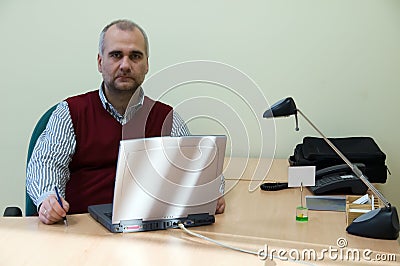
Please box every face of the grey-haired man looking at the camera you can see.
[97,25,149,93]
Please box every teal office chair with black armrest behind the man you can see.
[3,104,57,216]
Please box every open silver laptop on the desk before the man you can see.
[88,136,226,232]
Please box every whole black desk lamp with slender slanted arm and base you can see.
[263,97,399,239]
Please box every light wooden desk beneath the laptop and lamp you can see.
[0,160,400,265]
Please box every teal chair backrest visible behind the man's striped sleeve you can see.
[25,105,57,216]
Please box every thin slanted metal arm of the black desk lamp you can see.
[297,109,391,208]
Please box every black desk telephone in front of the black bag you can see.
[308,164,368,195]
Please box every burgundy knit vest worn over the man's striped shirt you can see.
[65,90,172,214]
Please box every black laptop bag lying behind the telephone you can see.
[289,137,388,183]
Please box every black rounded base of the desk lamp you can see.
[346,206,399,239]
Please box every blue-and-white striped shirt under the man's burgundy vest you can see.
[26,87,190,206]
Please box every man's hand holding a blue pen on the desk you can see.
[39,195,69,224]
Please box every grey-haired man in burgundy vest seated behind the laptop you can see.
[27,20,225,224]
